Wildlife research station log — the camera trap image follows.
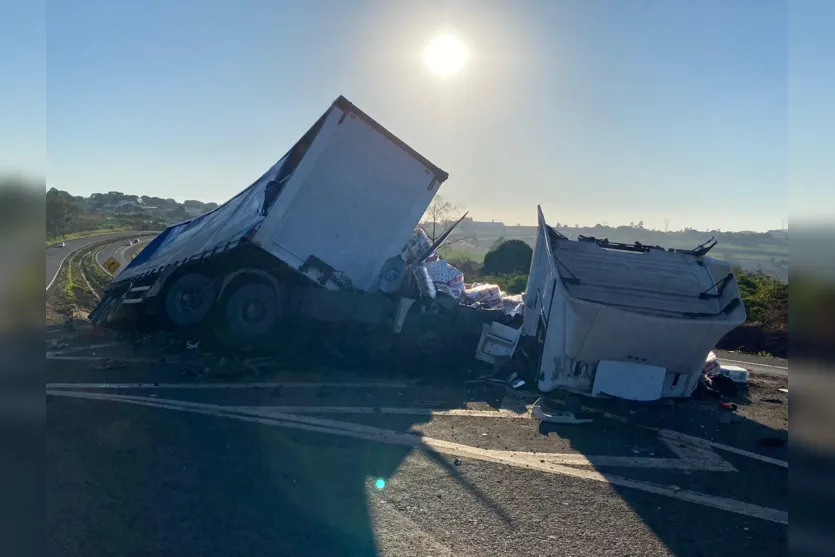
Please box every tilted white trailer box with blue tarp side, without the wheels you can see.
[114,97,448,292]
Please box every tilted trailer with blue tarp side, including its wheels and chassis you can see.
[90,97,510,347]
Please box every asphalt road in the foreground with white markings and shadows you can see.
[45,330,788,557]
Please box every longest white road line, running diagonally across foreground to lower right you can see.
[46,390,789,524]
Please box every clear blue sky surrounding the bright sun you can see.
[0,0,835,230]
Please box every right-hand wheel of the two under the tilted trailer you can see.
[225,282,279,340]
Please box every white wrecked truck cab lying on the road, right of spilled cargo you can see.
[518,208,745,400]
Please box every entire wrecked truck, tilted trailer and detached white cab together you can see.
[90,97,745,400]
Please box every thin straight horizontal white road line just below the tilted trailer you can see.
[46,378,422,390]
